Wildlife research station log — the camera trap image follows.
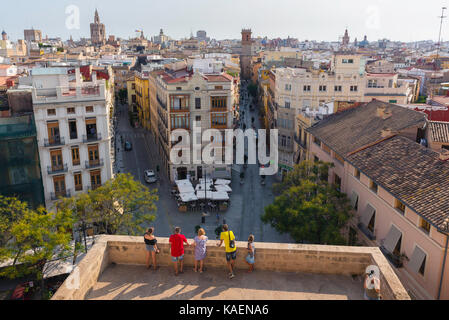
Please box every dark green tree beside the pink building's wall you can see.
[261,161,352,245]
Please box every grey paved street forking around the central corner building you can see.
[117,83,294,243]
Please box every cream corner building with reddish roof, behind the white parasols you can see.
[150,63,236,181]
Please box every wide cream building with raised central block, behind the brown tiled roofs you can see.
[267,54,414,175]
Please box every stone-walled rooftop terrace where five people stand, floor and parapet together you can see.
[52,235,410,300]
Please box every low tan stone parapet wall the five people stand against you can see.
[53,236,410,300]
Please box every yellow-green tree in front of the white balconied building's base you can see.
[58,173,158,235]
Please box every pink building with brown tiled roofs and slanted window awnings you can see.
[306,101,449,299]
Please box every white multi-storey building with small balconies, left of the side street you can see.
[27,68,114,207]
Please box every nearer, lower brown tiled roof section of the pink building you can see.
[347,136,449,228]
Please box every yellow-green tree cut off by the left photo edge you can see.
[0,197,74,279]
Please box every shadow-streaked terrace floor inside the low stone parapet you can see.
[86,264,363,300]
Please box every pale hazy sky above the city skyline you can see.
[0,0,449,42]
